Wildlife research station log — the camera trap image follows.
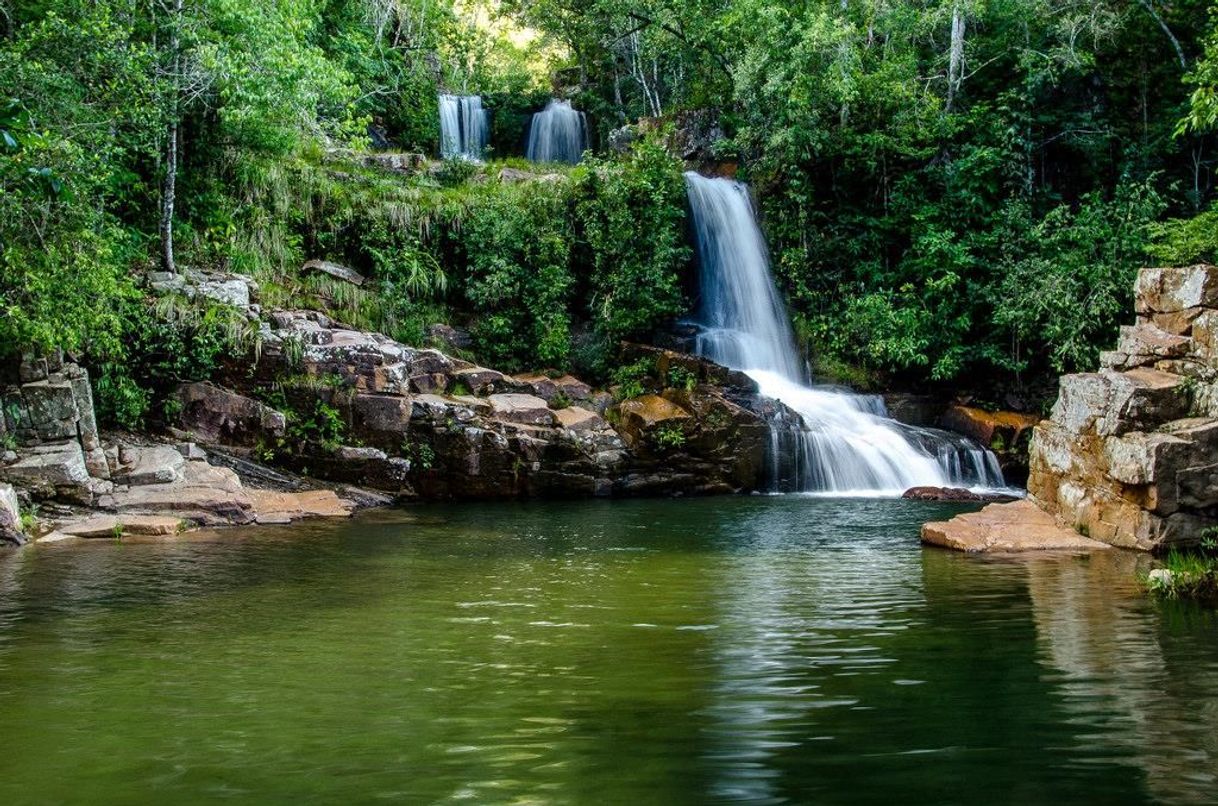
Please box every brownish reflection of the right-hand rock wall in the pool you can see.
[1024,552,1218,802]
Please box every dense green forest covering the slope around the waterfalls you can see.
[0,0,1218,426]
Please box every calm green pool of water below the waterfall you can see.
[0,497,1218,804]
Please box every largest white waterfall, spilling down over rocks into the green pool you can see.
[686,172,1004,494]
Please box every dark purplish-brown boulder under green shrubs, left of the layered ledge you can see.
[175,382,287,446]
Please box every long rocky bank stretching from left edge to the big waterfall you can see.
[0,267,793,542]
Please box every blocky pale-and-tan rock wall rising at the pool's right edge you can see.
[1028,265,1218,550]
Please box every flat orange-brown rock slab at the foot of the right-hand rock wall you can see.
[922,500,1112,553]
